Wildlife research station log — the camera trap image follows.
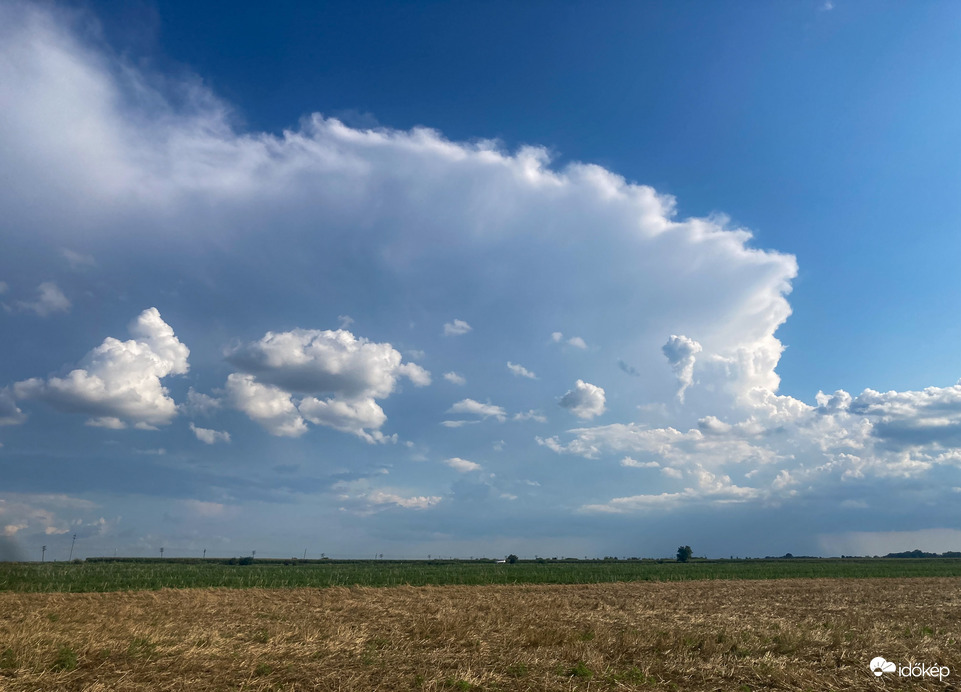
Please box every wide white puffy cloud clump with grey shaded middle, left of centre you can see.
[227,329,431,443]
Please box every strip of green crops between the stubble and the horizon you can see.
[0,558,961,592]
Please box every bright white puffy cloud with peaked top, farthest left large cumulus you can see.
[13,308,190,428]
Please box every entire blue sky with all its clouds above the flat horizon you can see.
[0,0,961,558]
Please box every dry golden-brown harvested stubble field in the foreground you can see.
[0,578,961,692]
